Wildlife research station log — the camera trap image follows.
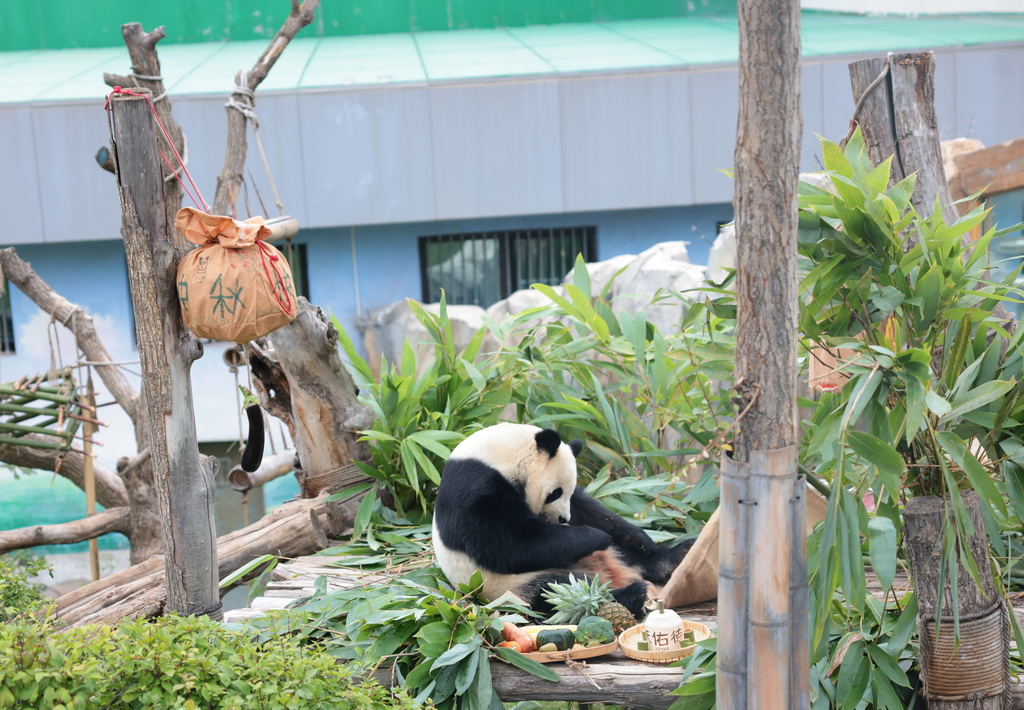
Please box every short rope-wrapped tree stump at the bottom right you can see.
[903,491,1010,710]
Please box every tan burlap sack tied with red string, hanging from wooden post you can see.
[174,207,298,343]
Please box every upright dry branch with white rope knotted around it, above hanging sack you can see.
[213,0,319,214]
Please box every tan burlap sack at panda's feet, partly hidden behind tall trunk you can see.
[659,487,828,608]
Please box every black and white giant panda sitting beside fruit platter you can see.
[433,423,690,618]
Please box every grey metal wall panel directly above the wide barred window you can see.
[430,80,563,219]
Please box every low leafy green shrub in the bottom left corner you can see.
[0,616,419,710]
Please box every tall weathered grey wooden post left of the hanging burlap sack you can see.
[111,89,220,617]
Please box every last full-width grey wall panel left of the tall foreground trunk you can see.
[561,72,693,212]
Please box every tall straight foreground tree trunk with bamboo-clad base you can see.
[718,0,809,708]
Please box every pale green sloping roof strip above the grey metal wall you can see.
[6,12,1024,103]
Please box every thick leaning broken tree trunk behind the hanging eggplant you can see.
[260,297,374,498]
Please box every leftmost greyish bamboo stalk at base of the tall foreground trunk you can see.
[716,457,750,708]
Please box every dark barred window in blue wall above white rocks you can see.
[420,226,597,308]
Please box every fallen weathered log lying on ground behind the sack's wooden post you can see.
[56,487,358,626]
